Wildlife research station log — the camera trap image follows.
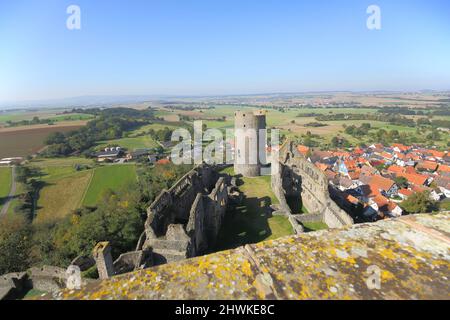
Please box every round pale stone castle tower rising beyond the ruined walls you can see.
[234,110,266,177]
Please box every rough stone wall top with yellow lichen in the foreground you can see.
[43,214,450,299]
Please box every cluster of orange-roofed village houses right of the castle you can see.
[298,143,450,221]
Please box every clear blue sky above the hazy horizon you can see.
[0,0,450,101]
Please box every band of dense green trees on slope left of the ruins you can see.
[0,164,192,274]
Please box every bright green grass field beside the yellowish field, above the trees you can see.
[83,165,137,206]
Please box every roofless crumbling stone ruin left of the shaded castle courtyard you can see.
[142,164,228,265]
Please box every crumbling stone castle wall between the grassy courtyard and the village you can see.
[272,142,353,228]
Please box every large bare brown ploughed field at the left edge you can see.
[0,123,82,158]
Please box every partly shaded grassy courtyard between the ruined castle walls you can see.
[216,167,293,250]
